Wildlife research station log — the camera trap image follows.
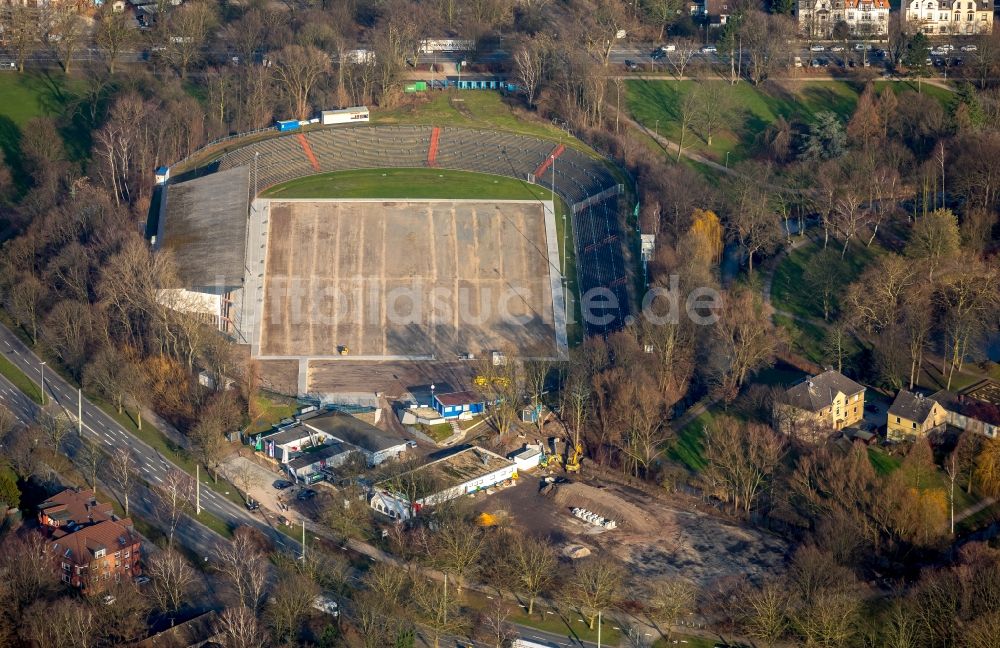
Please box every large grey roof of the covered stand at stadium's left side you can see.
[159,166,250,289]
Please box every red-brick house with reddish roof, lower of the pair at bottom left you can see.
[45,520,142,594]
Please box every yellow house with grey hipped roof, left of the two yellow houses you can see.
[776,369,865,441]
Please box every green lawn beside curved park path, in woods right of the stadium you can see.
[771,239,884,321]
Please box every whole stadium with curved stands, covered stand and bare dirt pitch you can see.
[150,125,633,395]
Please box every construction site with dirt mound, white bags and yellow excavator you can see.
[477,442,789,584]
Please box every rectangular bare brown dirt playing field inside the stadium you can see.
[260,200,558,360]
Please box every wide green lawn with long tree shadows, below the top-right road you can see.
[626,80,858,165]
